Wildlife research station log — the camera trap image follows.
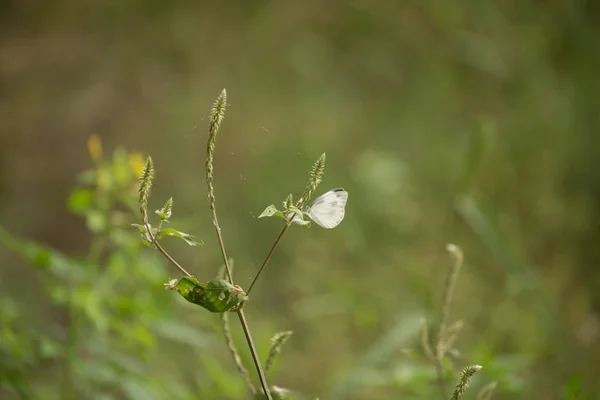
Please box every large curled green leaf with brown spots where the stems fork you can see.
[165,276,248,313]
